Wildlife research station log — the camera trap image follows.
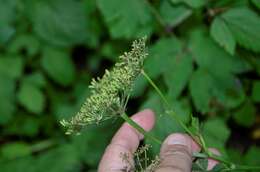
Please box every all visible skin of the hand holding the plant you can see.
[98,110,219,172]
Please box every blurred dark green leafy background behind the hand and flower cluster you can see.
[0,0,260,172]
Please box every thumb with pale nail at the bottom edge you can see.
[156,134,192,172]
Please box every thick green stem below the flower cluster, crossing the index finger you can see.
[121,113,162,145]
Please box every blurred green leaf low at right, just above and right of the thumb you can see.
[203,118,230,150]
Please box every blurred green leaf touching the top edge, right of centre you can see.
[160,0,192,27]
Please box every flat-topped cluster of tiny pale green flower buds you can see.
[61,38,147,134]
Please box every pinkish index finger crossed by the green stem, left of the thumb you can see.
[98,110,155,172]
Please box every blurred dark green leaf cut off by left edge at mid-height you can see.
[0,72,16,125]
